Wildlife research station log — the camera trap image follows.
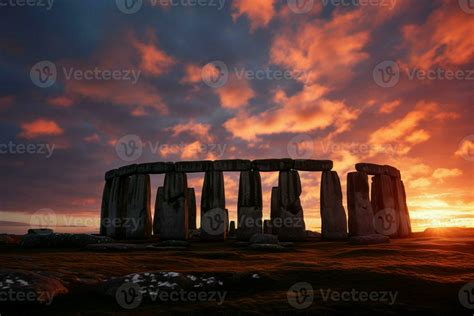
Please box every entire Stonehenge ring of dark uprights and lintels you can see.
[100,158,411,241]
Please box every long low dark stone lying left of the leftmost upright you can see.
[20,233,114,248]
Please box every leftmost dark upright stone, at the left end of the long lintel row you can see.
[105,176,129,239]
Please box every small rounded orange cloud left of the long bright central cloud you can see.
[216,75,255,109]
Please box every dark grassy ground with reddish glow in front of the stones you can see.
[0,229,474,315]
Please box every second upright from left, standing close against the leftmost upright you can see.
[124,174,152,239]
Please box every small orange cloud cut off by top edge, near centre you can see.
[232,0,275,32]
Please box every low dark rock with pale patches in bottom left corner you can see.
[0,269,68,305]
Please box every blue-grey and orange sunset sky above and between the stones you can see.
[0,0,474,232]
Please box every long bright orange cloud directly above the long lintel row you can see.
[224,85,358,141]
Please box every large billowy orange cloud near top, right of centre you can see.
[270,10,369,83]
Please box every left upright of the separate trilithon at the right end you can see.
[347,172,375,236]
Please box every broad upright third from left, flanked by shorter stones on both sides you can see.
[160,172,188,240]
